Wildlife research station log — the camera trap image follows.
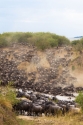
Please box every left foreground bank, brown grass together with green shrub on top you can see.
[0,86,20,125]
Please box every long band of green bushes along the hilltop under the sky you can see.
[0,32,70,50]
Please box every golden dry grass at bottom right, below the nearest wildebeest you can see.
[34,115,83,125]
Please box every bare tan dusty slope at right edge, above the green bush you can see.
[70,53,83,87]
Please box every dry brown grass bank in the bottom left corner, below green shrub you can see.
[0,100,20,125]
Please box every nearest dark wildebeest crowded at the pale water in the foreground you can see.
[13,89,80,116]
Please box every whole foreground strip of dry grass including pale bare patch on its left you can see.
[17,114,83,125]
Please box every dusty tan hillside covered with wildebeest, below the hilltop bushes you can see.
[0,44,83,94]
